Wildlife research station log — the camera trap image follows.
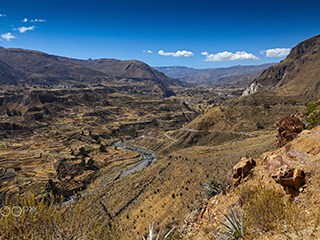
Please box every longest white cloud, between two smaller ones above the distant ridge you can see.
[201,51,259,62]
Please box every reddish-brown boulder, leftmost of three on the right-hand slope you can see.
[232,158,256,187]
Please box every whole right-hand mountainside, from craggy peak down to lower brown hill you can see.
[175,36,320,141]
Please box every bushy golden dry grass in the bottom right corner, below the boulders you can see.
[240,184,320,239]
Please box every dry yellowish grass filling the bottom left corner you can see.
[0,196,119,240]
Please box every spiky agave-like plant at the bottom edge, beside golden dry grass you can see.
[221,209,245,240]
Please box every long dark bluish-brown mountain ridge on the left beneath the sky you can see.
[0,48,180,96]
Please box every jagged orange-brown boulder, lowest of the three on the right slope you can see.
[272,166,306,195]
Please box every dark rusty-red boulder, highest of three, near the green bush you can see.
[277,116,305,147]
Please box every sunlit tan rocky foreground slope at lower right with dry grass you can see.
[184,124,320,240]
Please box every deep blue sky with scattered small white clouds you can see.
[0,0,320,68]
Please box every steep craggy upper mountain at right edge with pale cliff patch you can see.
[243,35,320,101]
